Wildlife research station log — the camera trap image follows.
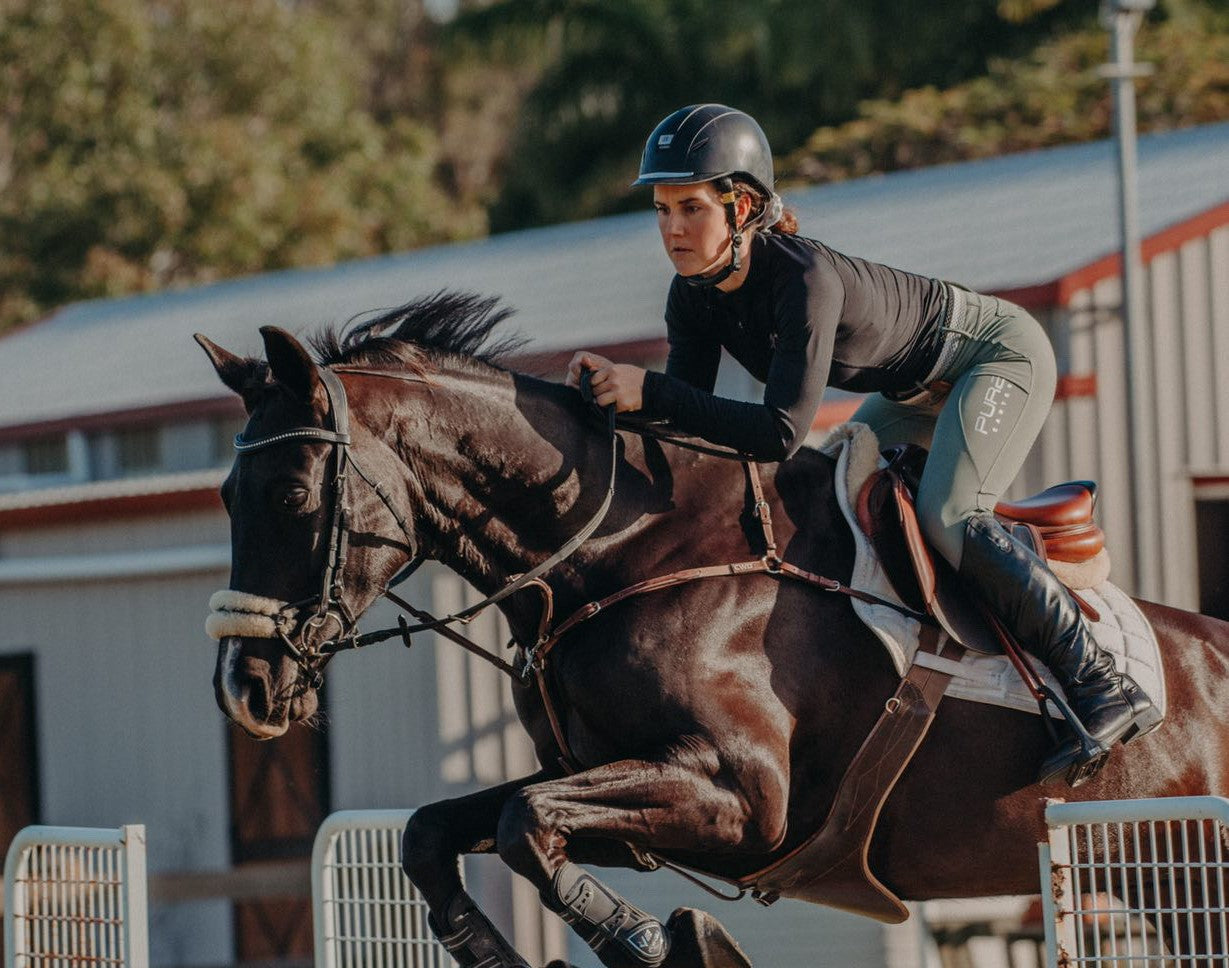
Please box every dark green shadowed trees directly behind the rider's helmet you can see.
[451,0,1095,228]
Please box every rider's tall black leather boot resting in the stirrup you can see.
[960,513,1160,786]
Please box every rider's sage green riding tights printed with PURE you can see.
[853,290,1057,569]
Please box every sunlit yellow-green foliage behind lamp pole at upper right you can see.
[780,4,1229,182]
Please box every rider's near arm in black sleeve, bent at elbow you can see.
[643,269,841,461]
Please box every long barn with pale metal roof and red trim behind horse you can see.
[0,124,1229,968]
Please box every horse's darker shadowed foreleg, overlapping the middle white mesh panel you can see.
[402,773,548,968]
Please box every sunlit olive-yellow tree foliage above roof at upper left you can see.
[0,0,485,327]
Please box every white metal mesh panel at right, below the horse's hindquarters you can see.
[1040,796,1229,968]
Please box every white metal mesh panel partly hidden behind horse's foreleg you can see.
[311,810,455,968]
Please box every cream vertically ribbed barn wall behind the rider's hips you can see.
[1030,227,1229,609]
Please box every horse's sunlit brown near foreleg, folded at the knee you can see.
[498,760,784,968]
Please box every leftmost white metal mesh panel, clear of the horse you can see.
[4,824,149,968]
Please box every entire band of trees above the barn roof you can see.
[0,0,1229,329]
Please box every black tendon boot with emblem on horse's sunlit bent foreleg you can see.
[546,861,670,968]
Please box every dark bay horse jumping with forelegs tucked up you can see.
[198,294,1229,968]
